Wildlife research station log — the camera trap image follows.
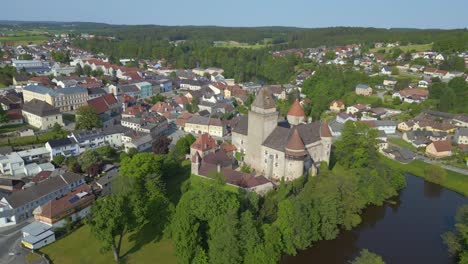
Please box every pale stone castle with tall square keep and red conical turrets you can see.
[232,87,332,181]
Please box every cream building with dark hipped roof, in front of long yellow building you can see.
[22,99,64,130]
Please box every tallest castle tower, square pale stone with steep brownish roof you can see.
[245,87,278,171]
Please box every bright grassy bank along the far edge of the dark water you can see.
[382,156,468,196]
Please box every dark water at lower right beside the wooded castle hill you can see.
[282,175,468,264]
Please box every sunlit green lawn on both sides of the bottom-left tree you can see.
[40,225,177,264]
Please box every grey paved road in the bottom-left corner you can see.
[0,221,30,264]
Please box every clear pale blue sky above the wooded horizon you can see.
[0,0,468,29]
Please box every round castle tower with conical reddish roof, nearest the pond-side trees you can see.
[285,128,307,181]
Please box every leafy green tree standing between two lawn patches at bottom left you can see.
[89,193,139,263]
